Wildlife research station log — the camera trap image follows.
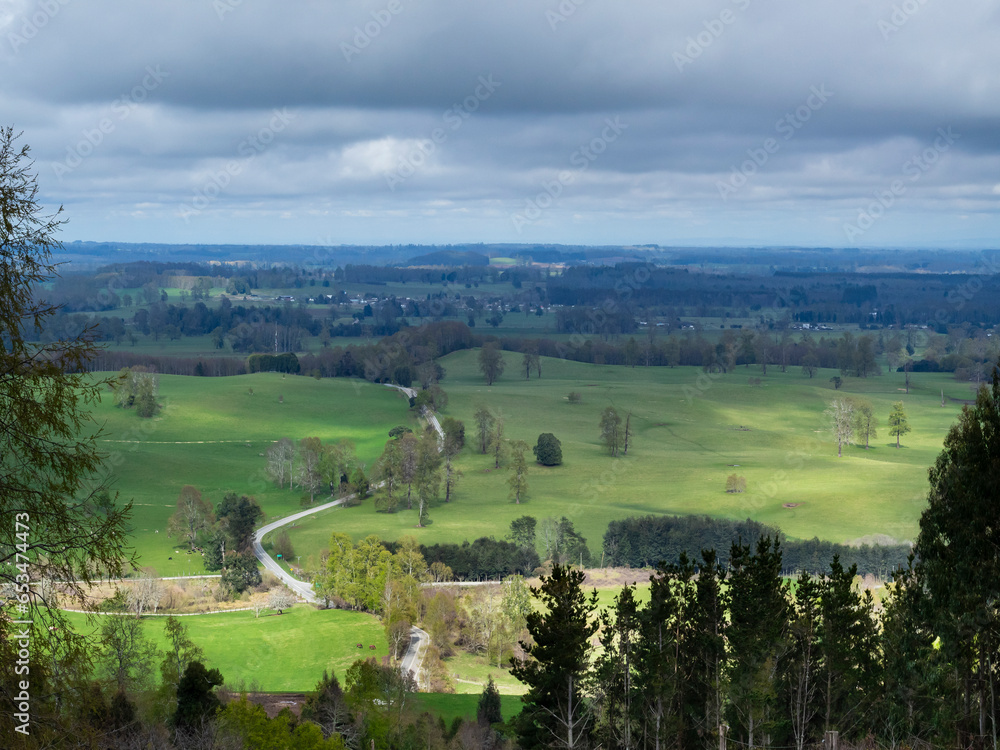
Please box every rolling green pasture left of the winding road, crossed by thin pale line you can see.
[87,373,414,575]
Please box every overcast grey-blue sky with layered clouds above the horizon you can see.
[0,0,1000,247]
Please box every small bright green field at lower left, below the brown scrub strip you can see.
[60,605,384,692]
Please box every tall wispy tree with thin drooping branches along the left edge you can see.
[0,126,134,744]
